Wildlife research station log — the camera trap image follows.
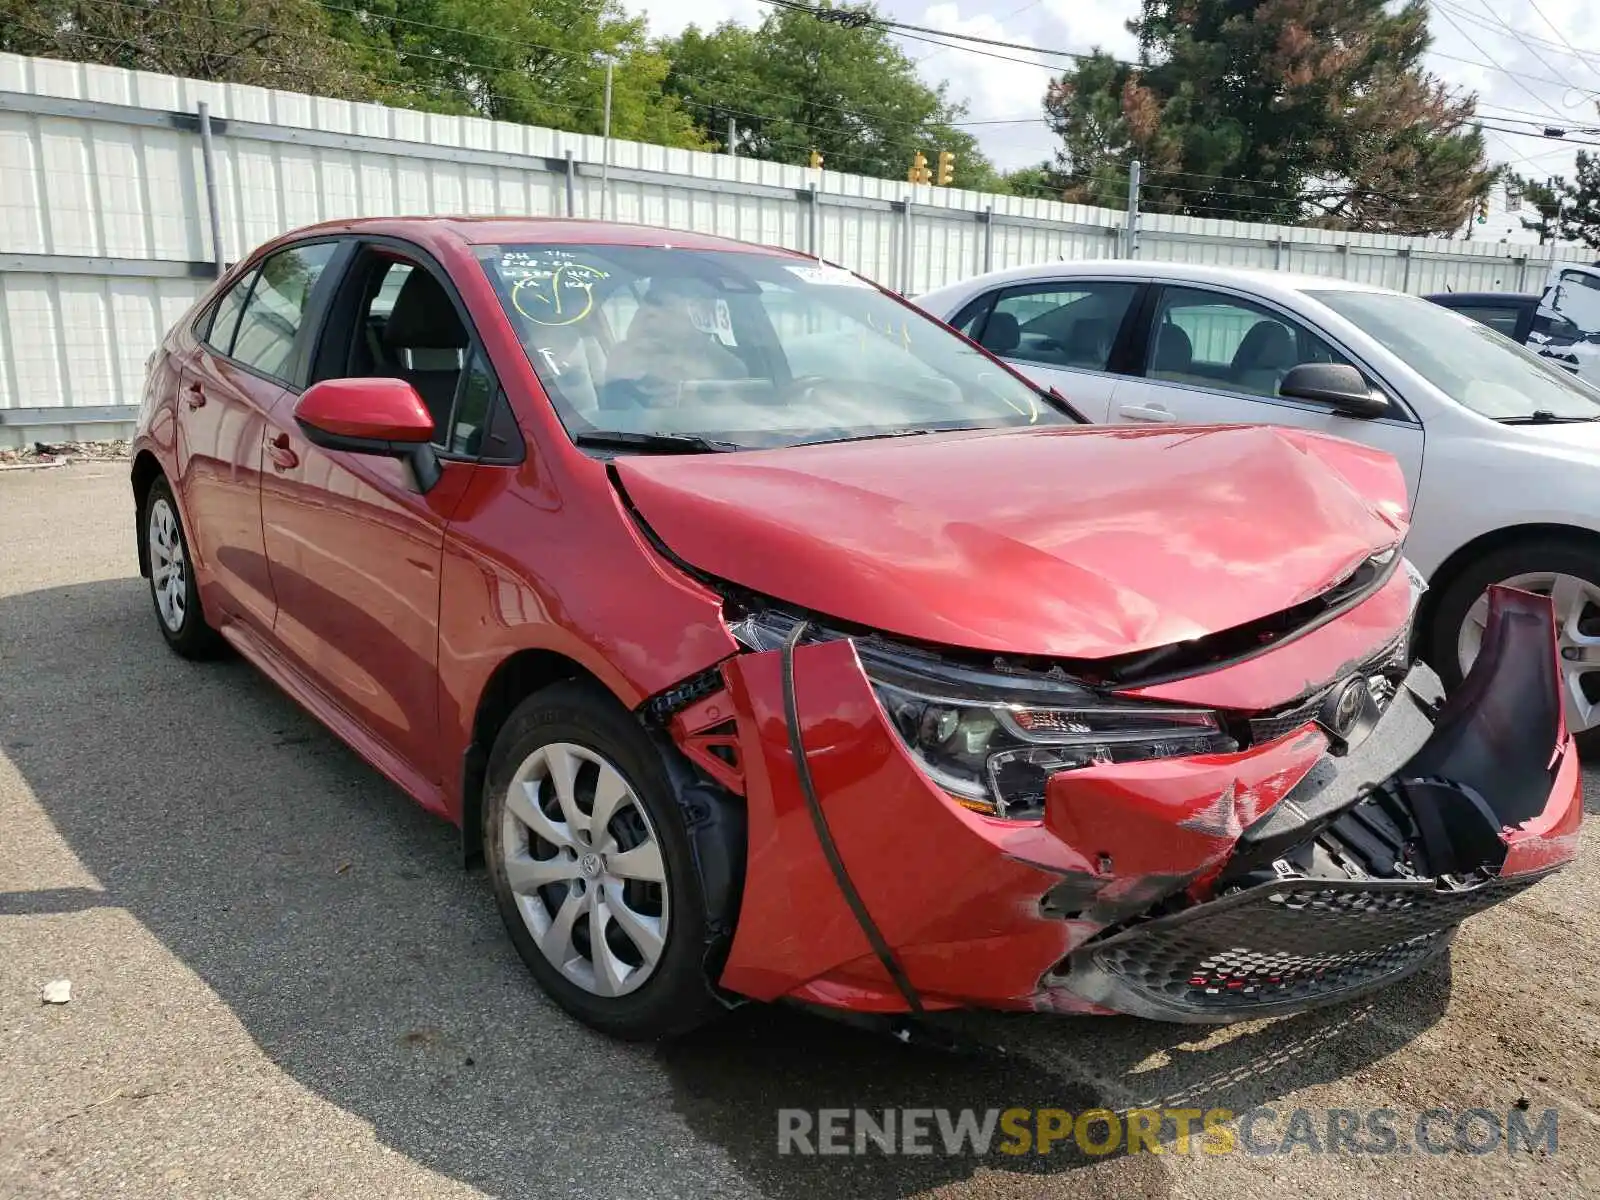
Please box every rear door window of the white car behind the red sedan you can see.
[981,283,1138,371]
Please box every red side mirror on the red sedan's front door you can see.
[294,378,440,493]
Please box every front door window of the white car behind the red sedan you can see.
[1146,288,1354,397]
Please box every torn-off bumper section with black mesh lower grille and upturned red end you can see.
[1046,587,1582,1021]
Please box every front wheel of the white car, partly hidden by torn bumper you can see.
[1427,538,1600,754]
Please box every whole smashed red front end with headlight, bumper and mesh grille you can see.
[662,578,1582,1021]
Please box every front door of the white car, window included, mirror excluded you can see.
[1112,285,1422,501]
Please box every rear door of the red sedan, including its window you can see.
[178,242,338,632]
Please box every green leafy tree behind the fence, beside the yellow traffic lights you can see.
[661,8,995,189]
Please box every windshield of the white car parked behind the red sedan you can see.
[1307,291,1600,421]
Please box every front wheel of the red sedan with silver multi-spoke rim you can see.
[483,682,720,1040]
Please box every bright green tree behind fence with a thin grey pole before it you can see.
[325,0,704,149]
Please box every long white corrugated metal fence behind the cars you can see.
[0,54,1587,446]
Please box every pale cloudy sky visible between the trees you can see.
[622,0,1600,242]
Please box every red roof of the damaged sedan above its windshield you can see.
[268,216,806,259]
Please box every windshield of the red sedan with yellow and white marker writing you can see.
[478,245,1077,450]
